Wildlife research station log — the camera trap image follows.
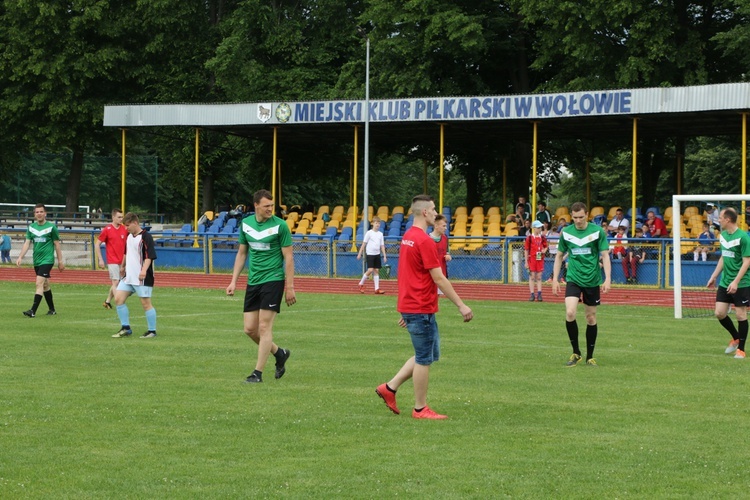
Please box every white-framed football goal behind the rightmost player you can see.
[671,194,750,318]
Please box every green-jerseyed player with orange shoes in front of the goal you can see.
[708,208,750,359]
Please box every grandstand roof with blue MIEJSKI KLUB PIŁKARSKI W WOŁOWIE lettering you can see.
[104,83,750,147]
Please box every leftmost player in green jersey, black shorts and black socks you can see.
[16,203,65,318]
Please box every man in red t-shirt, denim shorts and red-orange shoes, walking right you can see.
[375,195,474,420]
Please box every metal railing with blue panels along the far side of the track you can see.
[0,228,719,288]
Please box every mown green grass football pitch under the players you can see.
[0,282,750,498]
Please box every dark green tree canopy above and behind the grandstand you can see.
[0,0,750,214]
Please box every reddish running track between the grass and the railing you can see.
[0,265,674,307]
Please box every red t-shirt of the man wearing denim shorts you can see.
[397,226,440,314]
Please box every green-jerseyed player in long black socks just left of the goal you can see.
[552,202,612,366]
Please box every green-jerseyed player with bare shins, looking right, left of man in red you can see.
[227,189,297,383]
